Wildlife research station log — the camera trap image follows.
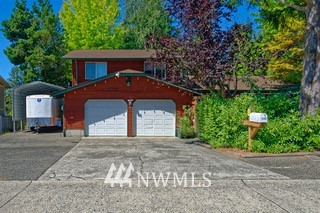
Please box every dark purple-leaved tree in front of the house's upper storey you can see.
[151,0,233,90]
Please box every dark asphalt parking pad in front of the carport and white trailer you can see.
[0,132,80,181]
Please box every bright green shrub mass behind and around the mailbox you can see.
[197,93,320,153]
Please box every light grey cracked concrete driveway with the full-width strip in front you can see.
[0,138,320,213]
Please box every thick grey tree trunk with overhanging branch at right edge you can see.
[249,0,320,116]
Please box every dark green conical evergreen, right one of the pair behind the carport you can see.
[25,0,71,86]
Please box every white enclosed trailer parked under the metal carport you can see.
[26,95,61,128]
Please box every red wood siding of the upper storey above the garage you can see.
[72,60,144,86]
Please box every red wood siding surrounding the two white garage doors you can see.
[64,77,193,136]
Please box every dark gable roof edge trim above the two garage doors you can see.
[51,69,201,97]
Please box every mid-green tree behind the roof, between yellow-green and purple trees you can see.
[124,0,172,49]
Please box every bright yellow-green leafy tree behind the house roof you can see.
[60,0,124,50]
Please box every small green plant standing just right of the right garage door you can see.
[178,106,195,138]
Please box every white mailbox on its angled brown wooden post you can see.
[243,112,268,150]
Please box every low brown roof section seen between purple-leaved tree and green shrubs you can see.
[226,76,285,91]
